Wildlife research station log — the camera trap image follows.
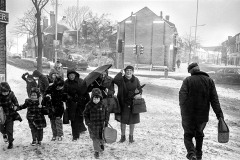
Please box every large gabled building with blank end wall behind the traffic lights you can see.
[117,7,177,70]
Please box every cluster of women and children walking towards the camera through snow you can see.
[0,62,142,158]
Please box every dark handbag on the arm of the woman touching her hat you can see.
[132,98,147,114]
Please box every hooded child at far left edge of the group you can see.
[0,82,21,149]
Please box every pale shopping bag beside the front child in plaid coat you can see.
[103,123,117,143]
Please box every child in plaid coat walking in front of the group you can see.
[83,88,109,159]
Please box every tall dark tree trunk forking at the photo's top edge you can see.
[32,0,49,72]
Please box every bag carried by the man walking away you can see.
[218,118,229,143]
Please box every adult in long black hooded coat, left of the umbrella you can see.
[63,69,90,141]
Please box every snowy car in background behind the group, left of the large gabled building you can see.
[58,53,88,71]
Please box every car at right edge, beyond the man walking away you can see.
[207,67,240,84]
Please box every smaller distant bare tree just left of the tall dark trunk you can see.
[13,8,38,55]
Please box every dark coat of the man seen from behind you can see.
[179,71,223,123]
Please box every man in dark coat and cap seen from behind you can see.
[179,63,223,160]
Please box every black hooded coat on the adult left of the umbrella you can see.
[63,69,90,121]
